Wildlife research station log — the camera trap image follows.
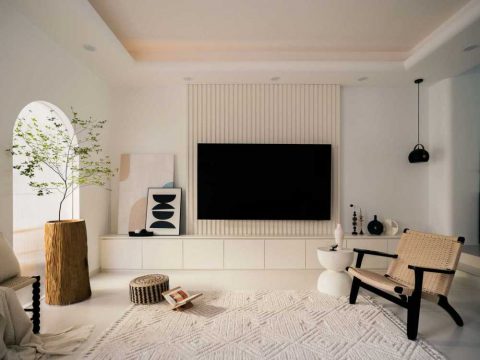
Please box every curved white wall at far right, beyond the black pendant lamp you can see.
[429,69,480,244]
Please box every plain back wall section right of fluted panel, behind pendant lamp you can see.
[341,83,430,232]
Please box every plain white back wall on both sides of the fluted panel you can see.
[111,83,430,236]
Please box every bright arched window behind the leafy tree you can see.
[12,101,79,273]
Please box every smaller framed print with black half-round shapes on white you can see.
[145,188,182,235]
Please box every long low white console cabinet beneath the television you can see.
[100,235,400,270]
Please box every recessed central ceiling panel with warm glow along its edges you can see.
[89,0,468,61]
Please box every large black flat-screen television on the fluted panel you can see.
[197,144,332,220]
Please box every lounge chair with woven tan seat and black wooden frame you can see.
[347,229,465,340]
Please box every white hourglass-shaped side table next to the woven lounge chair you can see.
[317,248,353,296]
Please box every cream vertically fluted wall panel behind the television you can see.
[187,84,340,236]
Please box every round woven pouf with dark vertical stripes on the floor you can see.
[130,274,169,304]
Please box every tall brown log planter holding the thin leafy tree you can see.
[45,220,92,305]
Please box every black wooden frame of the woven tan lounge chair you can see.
[347,237,465,340]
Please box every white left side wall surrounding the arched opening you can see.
[0,1,110,270]
